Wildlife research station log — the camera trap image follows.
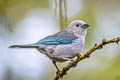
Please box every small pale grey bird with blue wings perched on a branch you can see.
[9,20,89,76]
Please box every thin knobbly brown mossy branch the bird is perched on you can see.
[54,37,120,80]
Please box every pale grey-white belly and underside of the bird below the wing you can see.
[38,38,84,62]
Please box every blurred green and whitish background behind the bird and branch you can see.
[0,0,120,80]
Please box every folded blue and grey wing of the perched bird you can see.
[37,31,77,45]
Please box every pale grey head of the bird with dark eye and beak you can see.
[65,20,89,36]
